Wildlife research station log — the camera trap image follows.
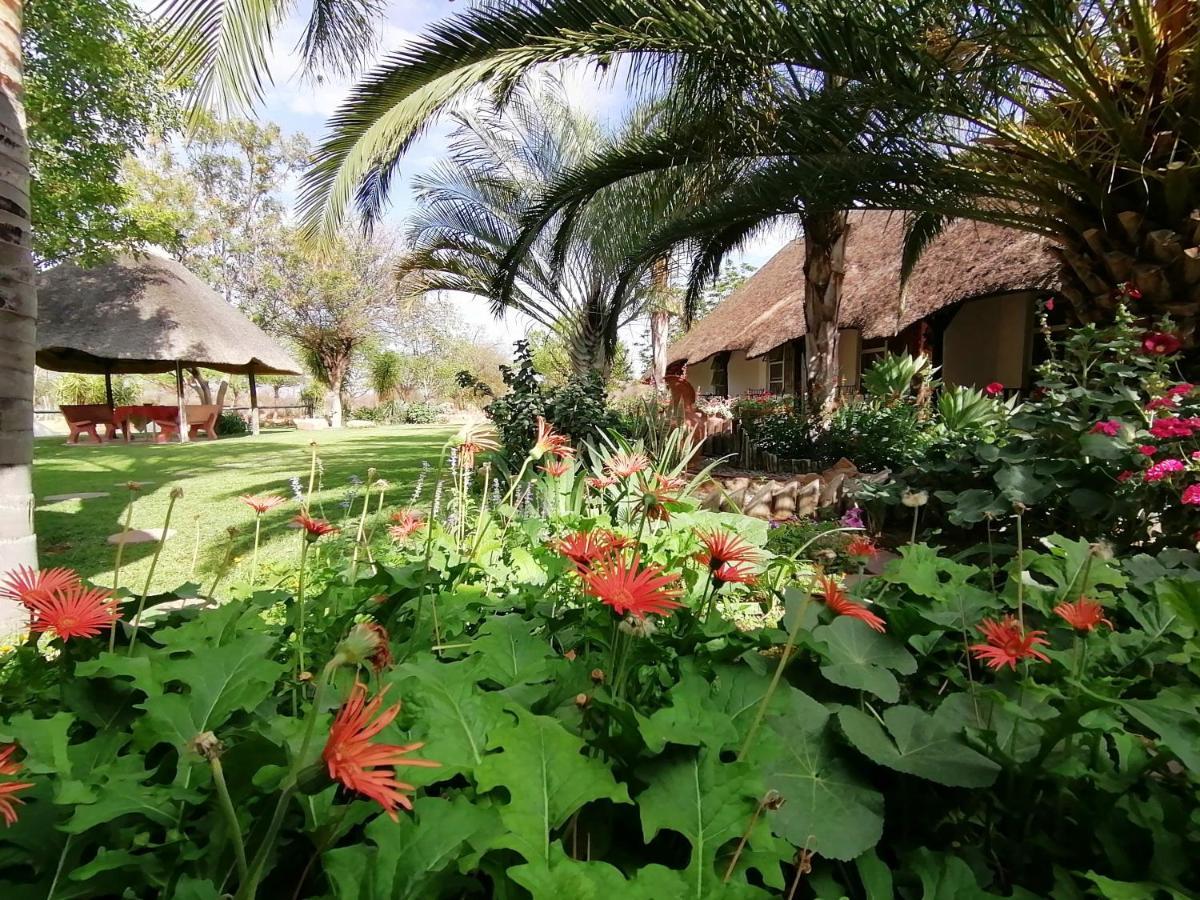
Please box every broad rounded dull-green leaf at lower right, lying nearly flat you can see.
[838,707,1000,787]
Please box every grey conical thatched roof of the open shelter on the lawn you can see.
[37,256,302,374]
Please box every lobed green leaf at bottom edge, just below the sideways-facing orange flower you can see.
[322,794,503,900]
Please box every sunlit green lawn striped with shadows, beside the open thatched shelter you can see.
[34,426,454,593]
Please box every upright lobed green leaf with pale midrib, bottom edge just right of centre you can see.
[637,750,762,898]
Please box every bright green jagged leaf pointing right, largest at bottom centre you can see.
[475,707,629,865]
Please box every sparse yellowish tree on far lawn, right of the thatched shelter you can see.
[250,232,396,428]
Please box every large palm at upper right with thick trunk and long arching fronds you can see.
[302,0,1200,364]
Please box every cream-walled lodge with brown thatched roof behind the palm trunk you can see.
[667,211,1058,396]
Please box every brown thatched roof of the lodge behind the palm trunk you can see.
[667,211,1058,362]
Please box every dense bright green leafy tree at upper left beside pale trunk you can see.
[22,0,175,263]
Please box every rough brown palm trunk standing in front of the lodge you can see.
[804,210,850,412]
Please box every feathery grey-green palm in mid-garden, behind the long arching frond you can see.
[398,78,649,376]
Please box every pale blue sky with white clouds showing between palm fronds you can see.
[159,0,788,355]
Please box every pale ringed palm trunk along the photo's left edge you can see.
[0,0,37,632]
